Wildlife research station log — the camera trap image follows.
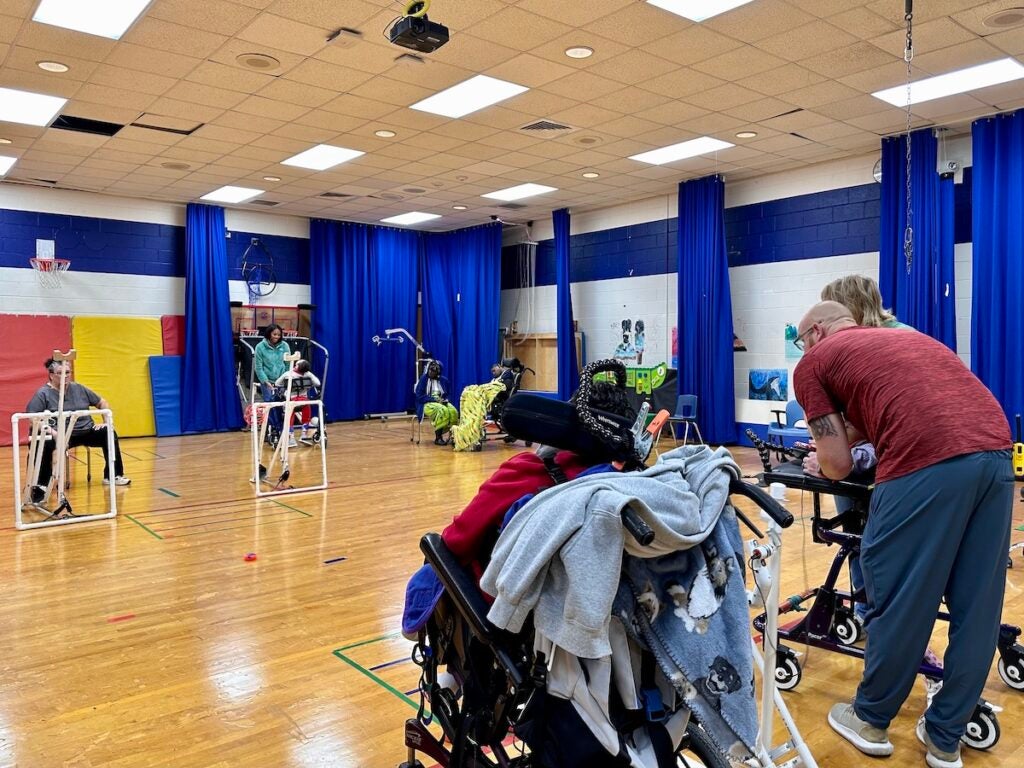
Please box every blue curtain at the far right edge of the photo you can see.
[971,111,1024,423]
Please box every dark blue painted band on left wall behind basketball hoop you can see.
[0,209,309,285]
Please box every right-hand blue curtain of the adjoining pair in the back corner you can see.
[421,222,502,398]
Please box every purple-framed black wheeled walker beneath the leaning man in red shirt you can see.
[748,433,1024,750]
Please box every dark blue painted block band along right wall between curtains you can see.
[502,176,971,289]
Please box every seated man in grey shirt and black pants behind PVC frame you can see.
[25,357,131,504]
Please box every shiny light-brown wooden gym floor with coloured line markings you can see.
[0,422,1024,768]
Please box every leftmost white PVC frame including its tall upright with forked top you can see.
[11,349,118,530]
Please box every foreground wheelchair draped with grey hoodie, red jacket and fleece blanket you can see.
[402,360,770,768]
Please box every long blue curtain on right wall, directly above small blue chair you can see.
[677,176,736,443]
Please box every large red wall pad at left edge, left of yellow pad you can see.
[0,314,72,445]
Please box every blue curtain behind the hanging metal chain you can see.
[879,128,956,351]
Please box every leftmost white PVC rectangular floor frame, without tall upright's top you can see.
[10,409,118,530]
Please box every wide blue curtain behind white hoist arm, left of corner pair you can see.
[309,219,420,420]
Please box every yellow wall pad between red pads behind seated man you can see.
[72,316,164,437]
